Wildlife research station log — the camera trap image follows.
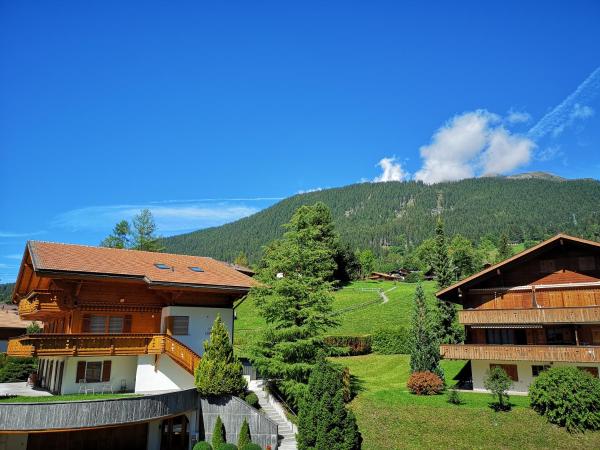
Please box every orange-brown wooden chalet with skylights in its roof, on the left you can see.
[7,241,254,392]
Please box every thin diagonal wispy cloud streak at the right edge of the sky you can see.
[528,67,600,140]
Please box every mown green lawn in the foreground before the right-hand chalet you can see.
[334,355,600,450]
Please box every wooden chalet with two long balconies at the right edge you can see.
[436,234,600,392]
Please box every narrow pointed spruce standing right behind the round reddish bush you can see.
[410,283,444,379]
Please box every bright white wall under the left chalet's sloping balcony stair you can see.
[135,354,194,392]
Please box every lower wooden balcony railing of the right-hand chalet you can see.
[440,344,600,363]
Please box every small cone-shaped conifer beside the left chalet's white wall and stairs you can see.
[195,316,246,396]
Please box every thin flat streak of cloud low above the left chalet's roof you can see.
[52,201,261,234]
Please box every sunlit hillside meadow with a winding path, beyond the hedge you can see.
[234,281,436,356]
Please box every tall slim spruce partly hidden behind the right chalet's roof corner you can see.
[433,218,461,344]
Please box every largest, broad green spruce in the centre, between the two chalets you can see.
[250,203,337,407]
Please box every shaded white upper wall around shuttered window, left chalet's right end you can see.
[161,306,233,355]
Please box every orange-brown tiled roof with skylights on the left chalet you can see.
[27,241,254,289]
